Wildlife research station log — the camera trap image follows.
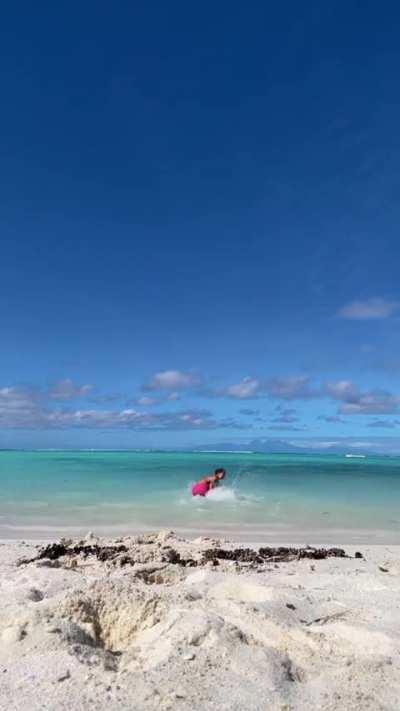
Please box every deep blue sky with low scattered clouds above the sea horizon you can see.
[0,1,400,447]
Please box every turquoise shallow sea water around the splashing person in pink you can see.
[0,451,400,543]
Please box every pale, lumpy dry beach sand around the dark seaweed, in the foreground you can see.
[0,532,400,711]
